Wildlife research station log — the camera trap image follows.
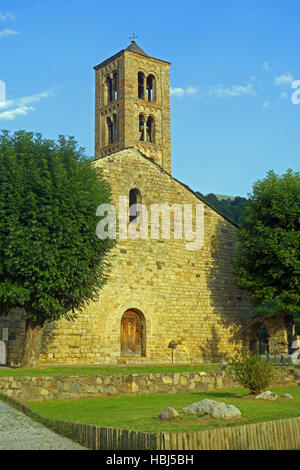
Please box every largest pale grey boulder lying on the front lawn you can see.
[182,399,241,419]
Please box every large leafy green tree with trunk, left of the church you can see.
[0,131,114,367]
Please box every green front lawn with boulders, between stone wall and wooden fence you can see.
[27,387,300,432]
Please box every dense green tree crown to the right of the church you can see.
[235,170,300,324]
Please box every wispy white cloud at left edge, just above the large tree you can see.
[0,90,54,121]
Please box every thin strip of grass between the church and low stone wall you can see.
[0,364,219,377]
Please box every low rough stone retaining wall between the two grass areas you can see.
[0,368,300,402]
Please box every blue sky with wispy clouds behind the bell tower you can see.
[0,0,300,196]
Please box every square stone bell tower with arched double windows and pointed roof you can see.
[94,39,171,173]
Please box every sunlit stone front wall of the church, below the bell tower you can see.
[0,149,255,364]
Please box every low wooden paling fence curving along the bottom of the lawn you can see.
[0,395,300,450]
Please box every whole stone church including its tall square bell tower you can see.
[0,40,292,364]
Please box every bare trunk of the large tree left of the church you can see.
[21,320,44,368]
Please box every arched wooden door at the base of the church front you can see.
[121,310,146,357]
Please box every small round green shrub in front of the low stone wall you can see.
[230,353,274,395]
